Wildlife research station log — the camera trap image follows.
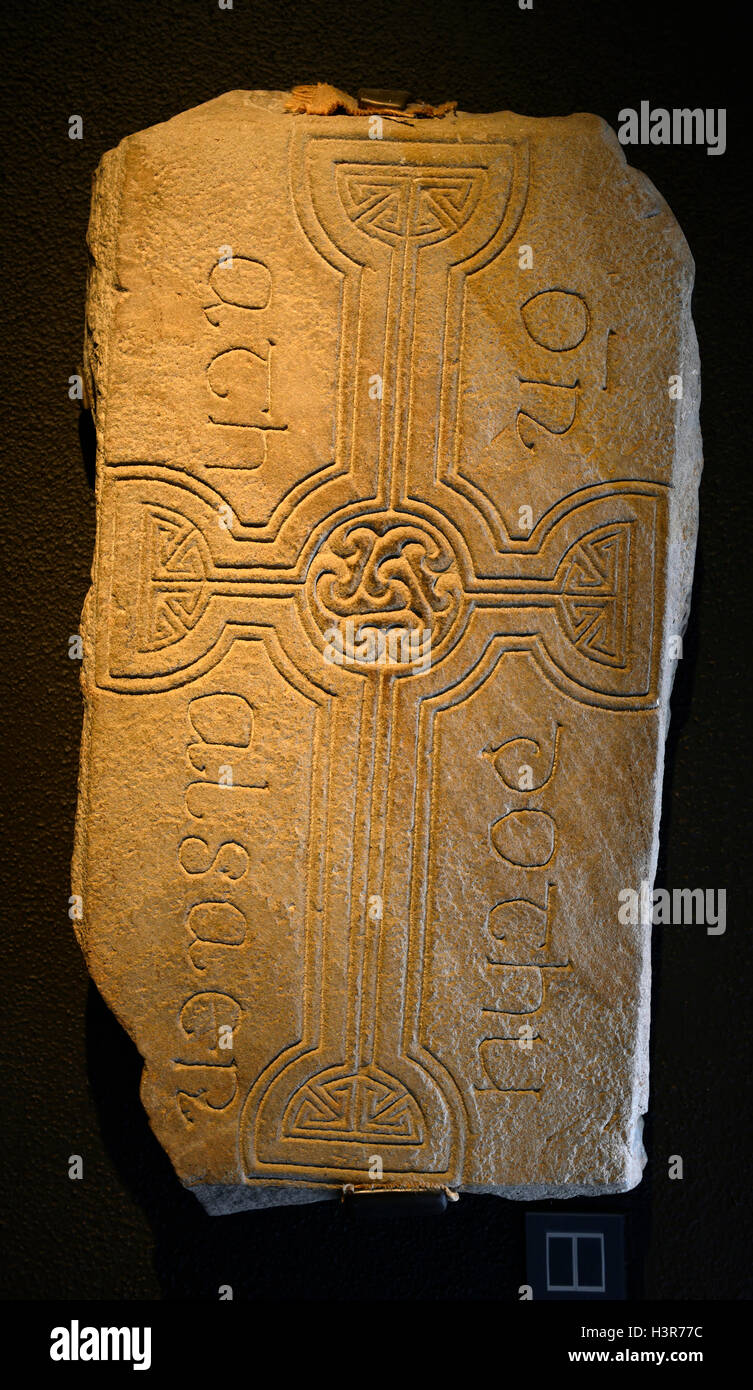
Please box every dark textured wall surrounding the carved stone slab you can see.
[0,0,752,1300]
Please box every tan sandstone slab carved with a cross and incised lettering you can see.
[74,89,700,1211]
